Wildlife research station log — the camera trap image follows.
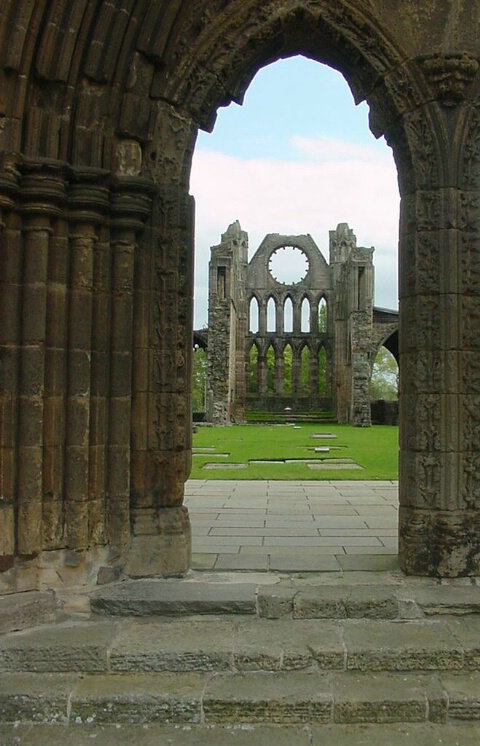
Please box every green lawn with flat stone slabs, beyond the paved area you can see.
[190,424,398,480]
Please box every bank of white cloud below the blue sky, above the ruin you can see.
[191,137,399,327]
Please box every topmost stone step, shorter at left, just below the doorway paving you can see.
[90,579,480,619]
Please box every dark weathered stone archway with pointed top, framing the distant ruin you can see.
[0,0,480,590]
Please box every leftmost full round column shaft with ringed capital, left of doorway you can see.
[17,162,66,556]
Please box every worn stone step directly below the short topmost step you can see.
[0,615,480,674]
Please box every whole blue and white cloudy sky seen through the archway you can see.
[190,57,399,329]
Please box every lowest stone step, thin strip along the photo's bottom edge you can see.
[0,723,480,746]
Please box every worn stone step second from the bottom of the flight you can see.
[0,671,480,724]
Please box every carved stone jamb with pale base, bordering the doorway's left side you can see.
[126,189,193,576]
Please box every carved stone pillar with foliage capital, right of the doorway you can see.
[399,55,480,577]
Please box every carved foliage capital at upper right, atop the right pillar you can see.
[421,52,480,106]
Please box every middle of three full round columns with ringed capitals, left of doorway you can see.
[63,169,109,550]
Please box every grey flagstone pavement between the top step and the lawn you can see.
[185,479,398,572]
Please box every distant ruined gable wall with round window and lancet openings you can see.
[207,221,398,427]
